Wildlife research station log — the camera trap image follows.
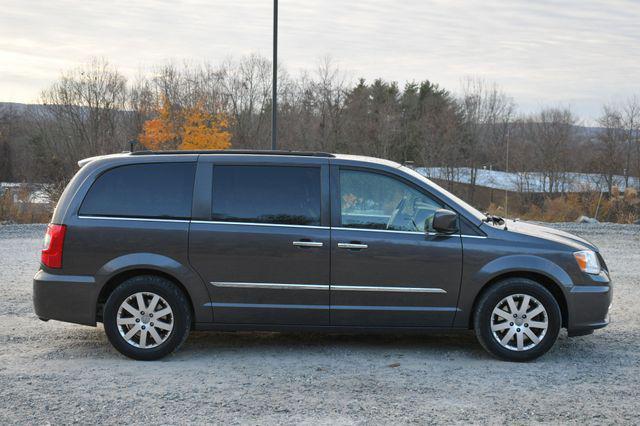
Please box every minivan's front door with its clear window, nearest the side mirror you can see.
[331,166,462,327]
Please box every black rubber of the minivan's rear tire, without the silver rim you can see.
[103,275,191,361]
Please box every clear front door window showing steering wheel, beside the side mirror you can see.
[340,170,442,232]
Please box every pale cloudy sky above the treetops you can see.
[0,0,640,122]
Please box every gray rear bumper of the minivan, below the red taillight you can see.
[33,269,96,326]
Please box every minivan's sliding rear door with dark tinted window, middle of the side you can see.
[189,162,330,325]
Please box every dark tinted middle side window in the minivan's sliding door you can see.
[212,166,320,225]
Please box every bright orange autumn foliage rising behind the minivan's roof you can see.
[139,98,231,150]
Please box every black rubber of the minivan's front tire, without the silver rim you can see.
[474,278,562,362]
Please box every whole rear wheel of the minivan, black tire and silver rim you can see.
[103,275,191,361]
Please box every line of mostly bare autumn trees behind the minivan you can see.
[0,55,640,206]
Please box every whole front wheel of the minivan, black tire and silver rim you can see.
[474,278,562,362]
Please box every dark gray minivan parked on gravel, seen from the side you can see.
[33,151,612,361]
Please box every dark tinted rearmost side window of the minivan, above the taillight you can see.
[80,163,196,219]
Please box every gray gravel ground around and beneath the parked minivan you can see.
[0,224,640,424]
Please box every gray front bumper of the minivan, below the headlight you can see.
[567,273,613,336]
